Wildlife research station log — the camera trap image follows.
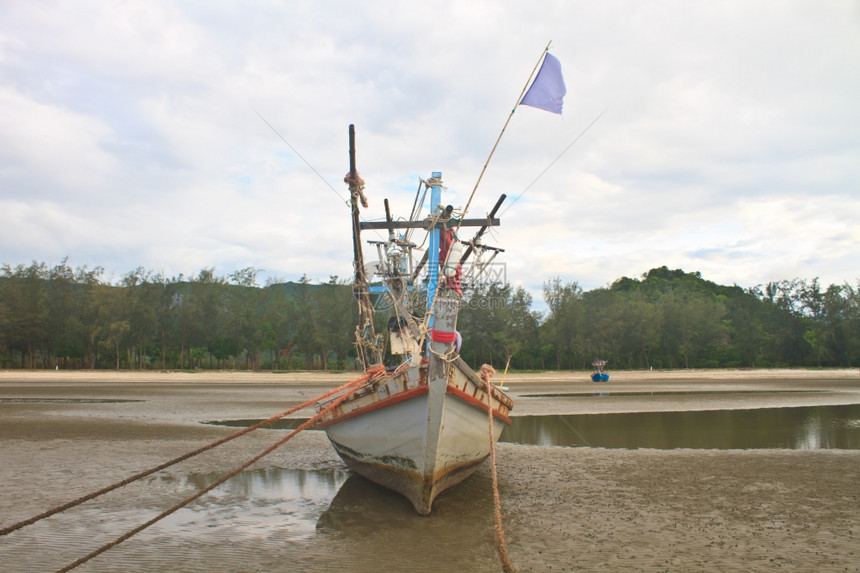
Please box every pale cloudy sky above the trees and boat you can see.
[0,0,860,303]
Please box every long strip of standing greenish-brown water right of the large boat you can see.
[501,404,860,450]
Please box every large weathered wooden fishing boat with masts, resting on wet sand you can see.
[317,125,513,515]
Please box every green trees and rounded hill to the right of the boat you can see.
[461,266,860,369]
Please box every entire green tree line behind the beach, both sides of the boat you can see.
[0,260,860,370]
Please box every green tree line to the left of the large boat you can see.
[0,261,356,370]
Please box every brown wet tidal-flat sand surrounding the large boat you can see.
[0,370,860,571]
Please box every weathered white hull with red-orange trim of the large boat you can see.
[319,359,512,515]
